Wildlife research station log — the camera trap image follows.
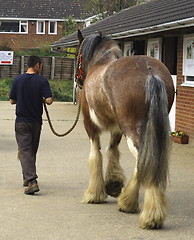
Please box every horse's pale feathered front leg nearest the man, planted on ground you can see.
[82,137,107,203]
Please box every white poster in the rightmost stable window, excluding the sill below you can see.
[183,35,194,76]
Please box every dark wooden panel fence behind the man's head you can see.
[0,56,74,80]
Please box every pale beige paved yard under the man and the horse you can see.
[0,102,194,240]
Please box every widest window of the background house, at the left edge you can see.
[0,20,28,33]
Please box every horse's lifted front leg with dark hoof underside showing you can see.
[105,131,125,197]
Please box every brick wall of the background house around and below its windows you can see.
[0,21,63,51]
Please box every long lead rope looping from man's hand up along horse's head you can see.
[43,38,86,137]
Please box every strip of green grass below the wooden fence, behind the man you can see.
[0,78,73,102]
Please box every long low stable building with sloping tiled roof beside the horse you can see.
[52,0,194,142]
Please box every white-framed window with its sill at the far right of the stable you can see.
[181,34,194,87]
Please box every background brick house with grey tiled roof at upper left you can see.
[0,0,87,50]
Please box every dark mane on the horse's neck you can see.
[82,33,117,62]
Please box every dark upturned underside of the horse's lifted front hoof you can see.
[105,180,123,198]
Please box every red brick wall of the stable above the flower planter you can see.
[176,35,194,142]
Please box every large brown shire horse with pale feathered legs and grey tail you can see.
[78,31,175,229]
